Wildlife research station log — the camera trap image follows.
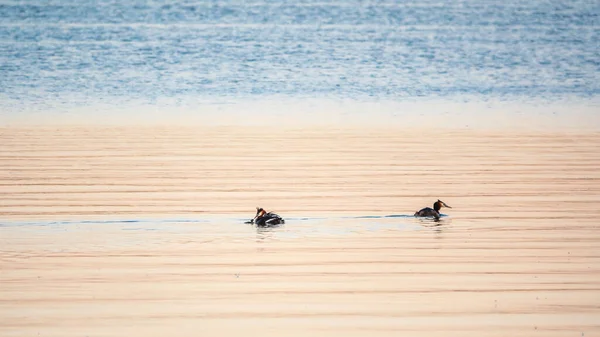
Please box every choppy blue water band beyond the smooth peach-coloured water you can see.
[0,0,600,113]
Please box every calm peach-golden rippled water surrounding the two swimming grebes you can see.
[0,127,600,336]
